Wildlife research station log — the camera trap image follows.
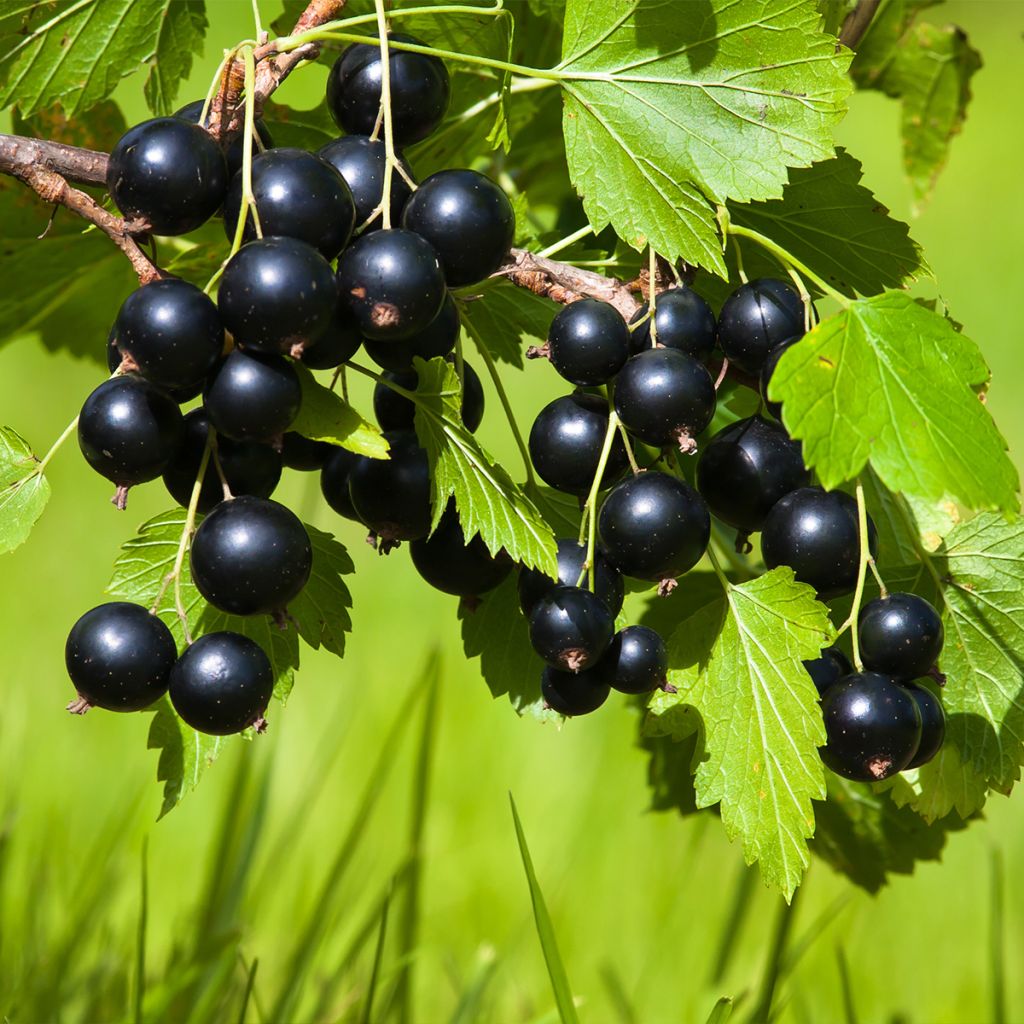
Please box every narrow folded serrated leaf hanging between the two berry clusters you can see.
[415,358,557,577]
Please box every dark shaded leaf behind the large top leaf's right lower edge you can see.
[729,150,931,296]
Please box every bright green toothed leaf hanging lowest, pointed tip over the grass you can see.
[651,567,835,899]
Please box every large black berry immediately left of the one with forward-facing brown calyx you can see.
[217,238,338,352]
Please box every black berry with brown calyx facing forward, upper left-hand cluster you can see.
[338,229,445,341]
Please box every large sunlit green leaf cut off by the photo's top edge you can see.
[555,0,850,274]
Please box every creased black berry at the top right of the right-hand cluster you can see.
[718,278,804,377]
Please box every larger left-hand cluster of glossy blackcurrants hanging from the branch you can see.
[66,35,515,734]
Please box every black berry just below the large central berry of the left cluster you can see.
[203,348,302,441]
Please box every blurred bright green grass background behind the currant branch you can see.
[0,0,1024,1024]
